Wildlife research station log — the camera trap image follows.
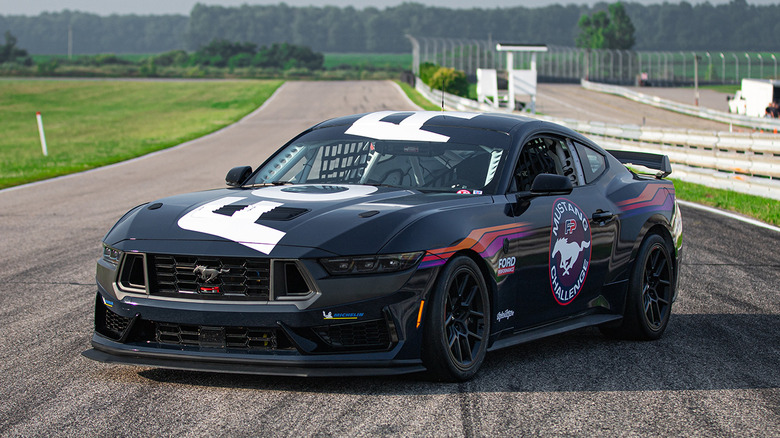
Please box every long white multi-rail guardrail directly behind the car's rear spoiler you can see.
[415,78,780,200]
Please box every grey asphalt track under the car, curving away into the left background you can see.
[0,82,780,437]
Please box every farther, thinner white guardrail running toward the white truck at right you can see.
[580,79,780,132]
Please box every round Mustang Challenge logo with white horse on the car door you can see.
[550,199,591,306]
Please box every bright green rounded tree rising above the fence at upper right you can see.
[575,2,635,50]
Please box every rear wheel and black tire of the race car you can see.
[601,234,676,341]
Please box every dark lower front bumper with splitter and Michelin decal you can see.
[83,269,435,376]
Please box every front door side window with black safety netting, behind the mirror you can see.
[510,137,580,191]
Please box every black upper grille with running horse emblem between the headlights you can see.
[149,254,270,301]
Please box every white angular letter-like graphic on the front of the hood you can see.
[178,196,285,254]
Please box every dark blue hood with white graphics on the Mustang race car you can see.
[104,185,492,257]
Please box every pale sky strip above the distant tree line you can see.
[0,0,780,15]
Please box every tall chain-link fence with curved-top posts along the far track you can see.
[407,36,780,86]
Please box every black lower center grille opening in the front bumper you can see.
[155,322,293,351]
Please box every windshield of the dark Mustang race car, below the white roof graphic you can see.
[249,128,507,194]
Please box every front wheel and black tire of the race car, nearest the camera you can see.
[422,256,490,382]
